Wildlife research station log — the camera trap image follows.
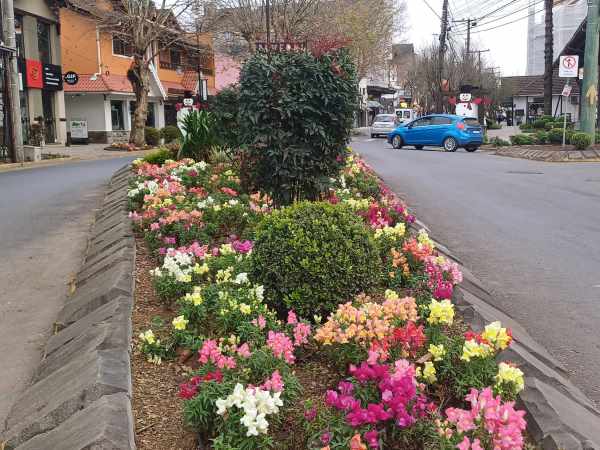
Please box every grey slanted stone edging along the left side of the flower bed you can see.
[0,165,136,450]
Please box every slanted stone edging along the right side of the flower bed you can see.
[412,221,600,450]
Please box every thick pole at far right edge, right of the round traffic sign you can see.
[581,0,600,142]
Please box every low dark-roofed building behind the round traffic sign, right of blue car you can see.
[501,70,579,125]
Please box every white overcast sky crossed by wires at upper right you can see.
[402,0,527,76]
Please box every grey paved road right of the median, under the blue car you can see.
[352,137,600,406]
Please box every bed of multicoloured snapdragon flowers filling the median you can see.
[129,153,526,450]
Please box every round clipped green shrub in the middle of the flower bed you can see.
[251,202,381,317]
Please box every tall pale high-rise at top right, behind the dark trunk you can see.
[526,0,587,75]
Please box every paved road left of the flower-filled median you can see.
[0,158,131,430]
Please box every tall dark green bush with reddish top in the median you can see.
[239,50,357,205]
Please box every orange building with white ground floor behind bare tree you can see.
[60,3,215,143]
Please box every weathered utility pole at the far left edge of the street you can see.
[0,0,24,163]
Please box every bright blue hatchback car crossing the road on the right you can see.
[388,114,483,152]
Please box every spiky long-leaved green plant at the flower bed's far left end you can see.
[177,111,218,161]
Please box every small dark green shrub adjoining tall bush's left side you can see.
[209,87,241,149]
